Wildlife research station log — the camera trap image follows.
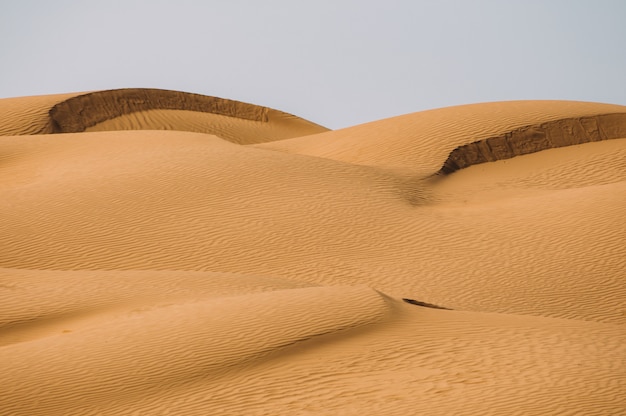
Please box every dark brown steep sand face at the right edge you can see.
[437,113,626,175]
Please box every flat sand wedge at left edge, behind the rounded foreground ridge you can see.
[0,269,310,346]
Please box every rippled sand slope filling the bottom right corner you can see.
[138,305,625,416]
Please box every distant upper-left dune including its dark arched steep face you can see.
[0,88,328,144]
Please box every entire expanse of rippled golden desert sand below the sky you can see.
[0,89,626,416]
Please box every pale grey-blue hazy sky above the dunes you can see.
[0,0,626,129]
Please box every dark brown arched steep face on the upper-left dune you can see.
[49,88,270,133]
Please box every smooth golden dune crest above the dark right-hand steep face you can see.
[263,101,626,175]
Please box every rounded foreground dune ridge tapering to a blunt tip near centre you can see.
[0,287,388,415]
